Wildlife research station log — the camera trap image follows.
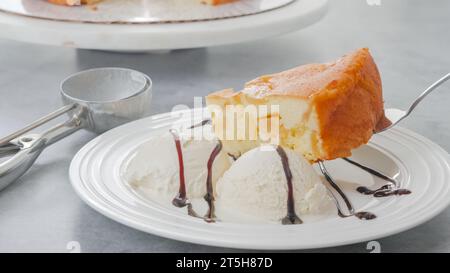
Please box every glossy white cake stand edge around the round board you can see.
[0,0,328,51]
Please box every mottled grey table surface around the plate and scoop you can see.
[0,0,450,252]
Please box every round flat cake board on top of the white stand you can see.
[0,0,294,24]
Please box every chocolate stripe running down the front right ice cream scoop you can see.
[277,146,303,222]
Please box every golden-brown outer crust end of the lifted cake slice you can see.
[312,48,388,159]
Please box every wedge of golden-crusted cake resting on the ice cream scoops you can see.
[206,48,389,161]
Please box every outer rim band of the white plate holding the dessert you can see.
[69,110,450,250]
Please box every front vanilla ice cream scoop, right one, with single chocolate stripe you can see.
[216,146,333,221]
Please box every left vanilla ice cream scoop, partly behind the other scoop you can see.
[125,125,230,199]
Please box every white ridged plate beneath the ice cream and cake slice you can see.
[70,108,450,249]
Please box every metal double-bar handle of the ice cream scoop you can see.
[0,105,83,190]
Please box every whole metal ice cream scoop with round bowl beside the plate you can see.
[0,67,152,190]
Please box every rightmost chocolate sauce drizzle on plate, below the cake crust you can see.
[342,158,411,197]
